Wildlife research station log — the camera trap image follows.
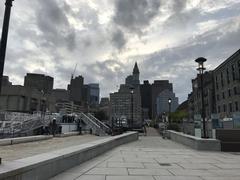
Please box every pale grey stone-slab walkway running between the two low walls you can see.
[51,136,240,180]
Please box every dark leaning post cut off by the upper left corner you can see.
[0,0,14,94]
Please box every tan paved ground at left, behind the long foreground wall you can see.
[0,135,104,161]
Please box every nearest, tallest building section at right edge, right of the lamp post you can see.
[214,50,240,118]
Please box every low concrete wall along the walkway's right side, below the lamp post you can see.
[168,130,221,151]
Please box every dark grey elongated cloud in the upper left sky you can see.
[36,0,76,50]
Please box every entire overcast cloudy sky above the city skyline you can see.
[0,0,240,101]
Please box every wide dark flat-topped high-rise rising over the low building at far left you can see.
[24,73,54,94]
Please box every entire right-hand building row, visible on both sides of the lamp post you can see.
[188,50,240,120]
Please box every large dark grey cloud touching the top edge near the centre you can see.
[113,0,160,34]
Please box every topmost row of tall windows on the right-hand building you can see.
[215,61,240,90]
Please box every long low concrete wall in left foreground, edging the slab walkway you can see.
[0,132,138,180]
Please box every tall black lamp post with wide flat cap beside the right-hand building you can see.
[195,57,207,138]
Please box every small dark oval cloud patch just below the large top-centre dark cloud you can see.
[112,29,127,50]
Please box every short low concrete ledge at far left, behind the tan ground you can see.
[0,135,53,146]
